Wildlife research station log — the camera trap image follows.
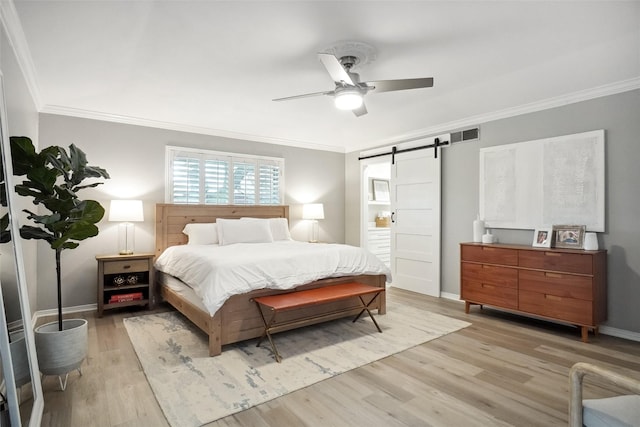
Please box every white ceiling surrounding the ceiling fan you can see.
[8,0,640,152]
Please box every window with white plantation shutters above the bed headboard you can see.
[166,147,284,205]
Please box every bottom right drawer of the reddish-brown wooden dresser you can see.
[518,289,594,325]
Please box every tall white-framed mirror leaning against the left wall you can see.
[0,73,44,426]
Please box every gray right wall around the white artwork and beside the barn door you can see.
[346,90,640,332]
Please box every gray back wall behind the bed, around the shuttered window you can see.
[38,114,345,310]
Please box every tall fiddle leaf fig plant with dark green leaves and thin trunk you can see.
[10,136,109,330]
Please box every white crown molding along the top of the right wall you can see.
[346,77,640,153]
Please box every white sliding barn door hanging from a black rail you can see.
[390,145,440,297]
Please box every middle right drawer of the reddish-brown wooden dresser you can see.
[519,270,593,301]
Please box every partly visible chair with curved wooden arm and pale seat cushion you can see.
[569,362,640,427]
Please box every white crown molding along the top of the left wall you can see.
[0,0,43,110]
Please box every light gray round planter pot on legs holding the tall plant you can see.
[35,319,88,390]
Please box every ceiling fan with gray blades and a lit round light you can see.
[274,53,433,117]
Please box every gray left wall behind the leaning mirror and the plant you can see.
[0,20,38,322]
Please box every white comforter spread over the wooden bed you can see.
[155,241,391,315]
